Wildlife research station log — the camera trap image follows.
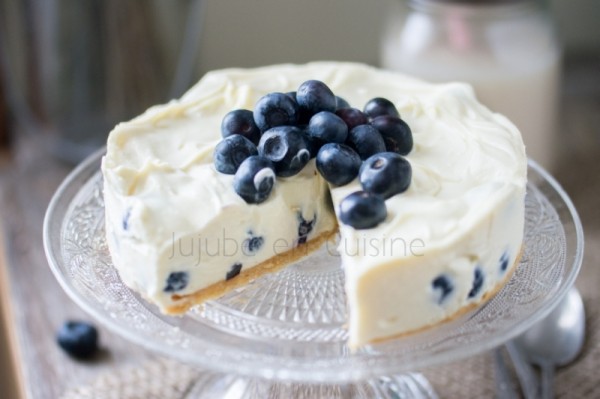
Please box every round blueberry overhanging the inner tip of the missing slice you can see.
[316,143,361,186]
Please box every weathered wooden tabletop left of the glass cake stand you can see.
[0,137,149,398]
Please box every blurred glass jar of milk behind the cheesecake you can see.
[381,0,561,168]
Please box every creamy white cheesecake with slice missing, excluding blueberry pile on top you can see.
[102,62,527,347]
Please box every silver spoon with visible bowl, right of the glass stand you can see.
[515,287,585,399]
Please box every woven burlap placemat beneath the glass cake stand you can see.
[63,297,600,399]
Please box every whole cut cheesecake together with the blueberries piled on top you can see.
[103,63,526,347]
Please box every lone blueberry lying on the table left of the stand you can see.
[56,321,98,359]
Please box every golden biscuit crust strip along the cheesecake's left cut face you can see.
[161,228,338,315]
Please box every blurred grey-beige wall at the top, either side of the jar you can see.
[199,0,600,72]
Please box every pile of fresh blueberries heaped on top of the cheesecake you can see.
[214,80,413,229]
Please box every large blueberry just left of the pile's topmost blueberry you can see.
[254,93,298,132]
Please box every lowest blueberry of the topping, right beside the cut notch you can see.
[339,191,387,229]
